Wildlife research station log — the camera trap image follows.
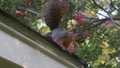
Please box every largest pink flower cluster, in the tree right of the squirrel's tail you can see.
[74,12,86,25]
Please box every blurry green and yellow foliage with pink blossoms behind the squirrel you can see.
[0,0,120,68]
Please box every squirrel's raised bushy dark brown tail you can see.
[44,0,69,30]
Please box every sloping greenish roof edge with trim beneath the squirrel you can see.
[0,10,87,68]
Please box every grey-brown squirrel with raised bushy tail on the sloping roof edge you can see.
[43,0,84,53]
